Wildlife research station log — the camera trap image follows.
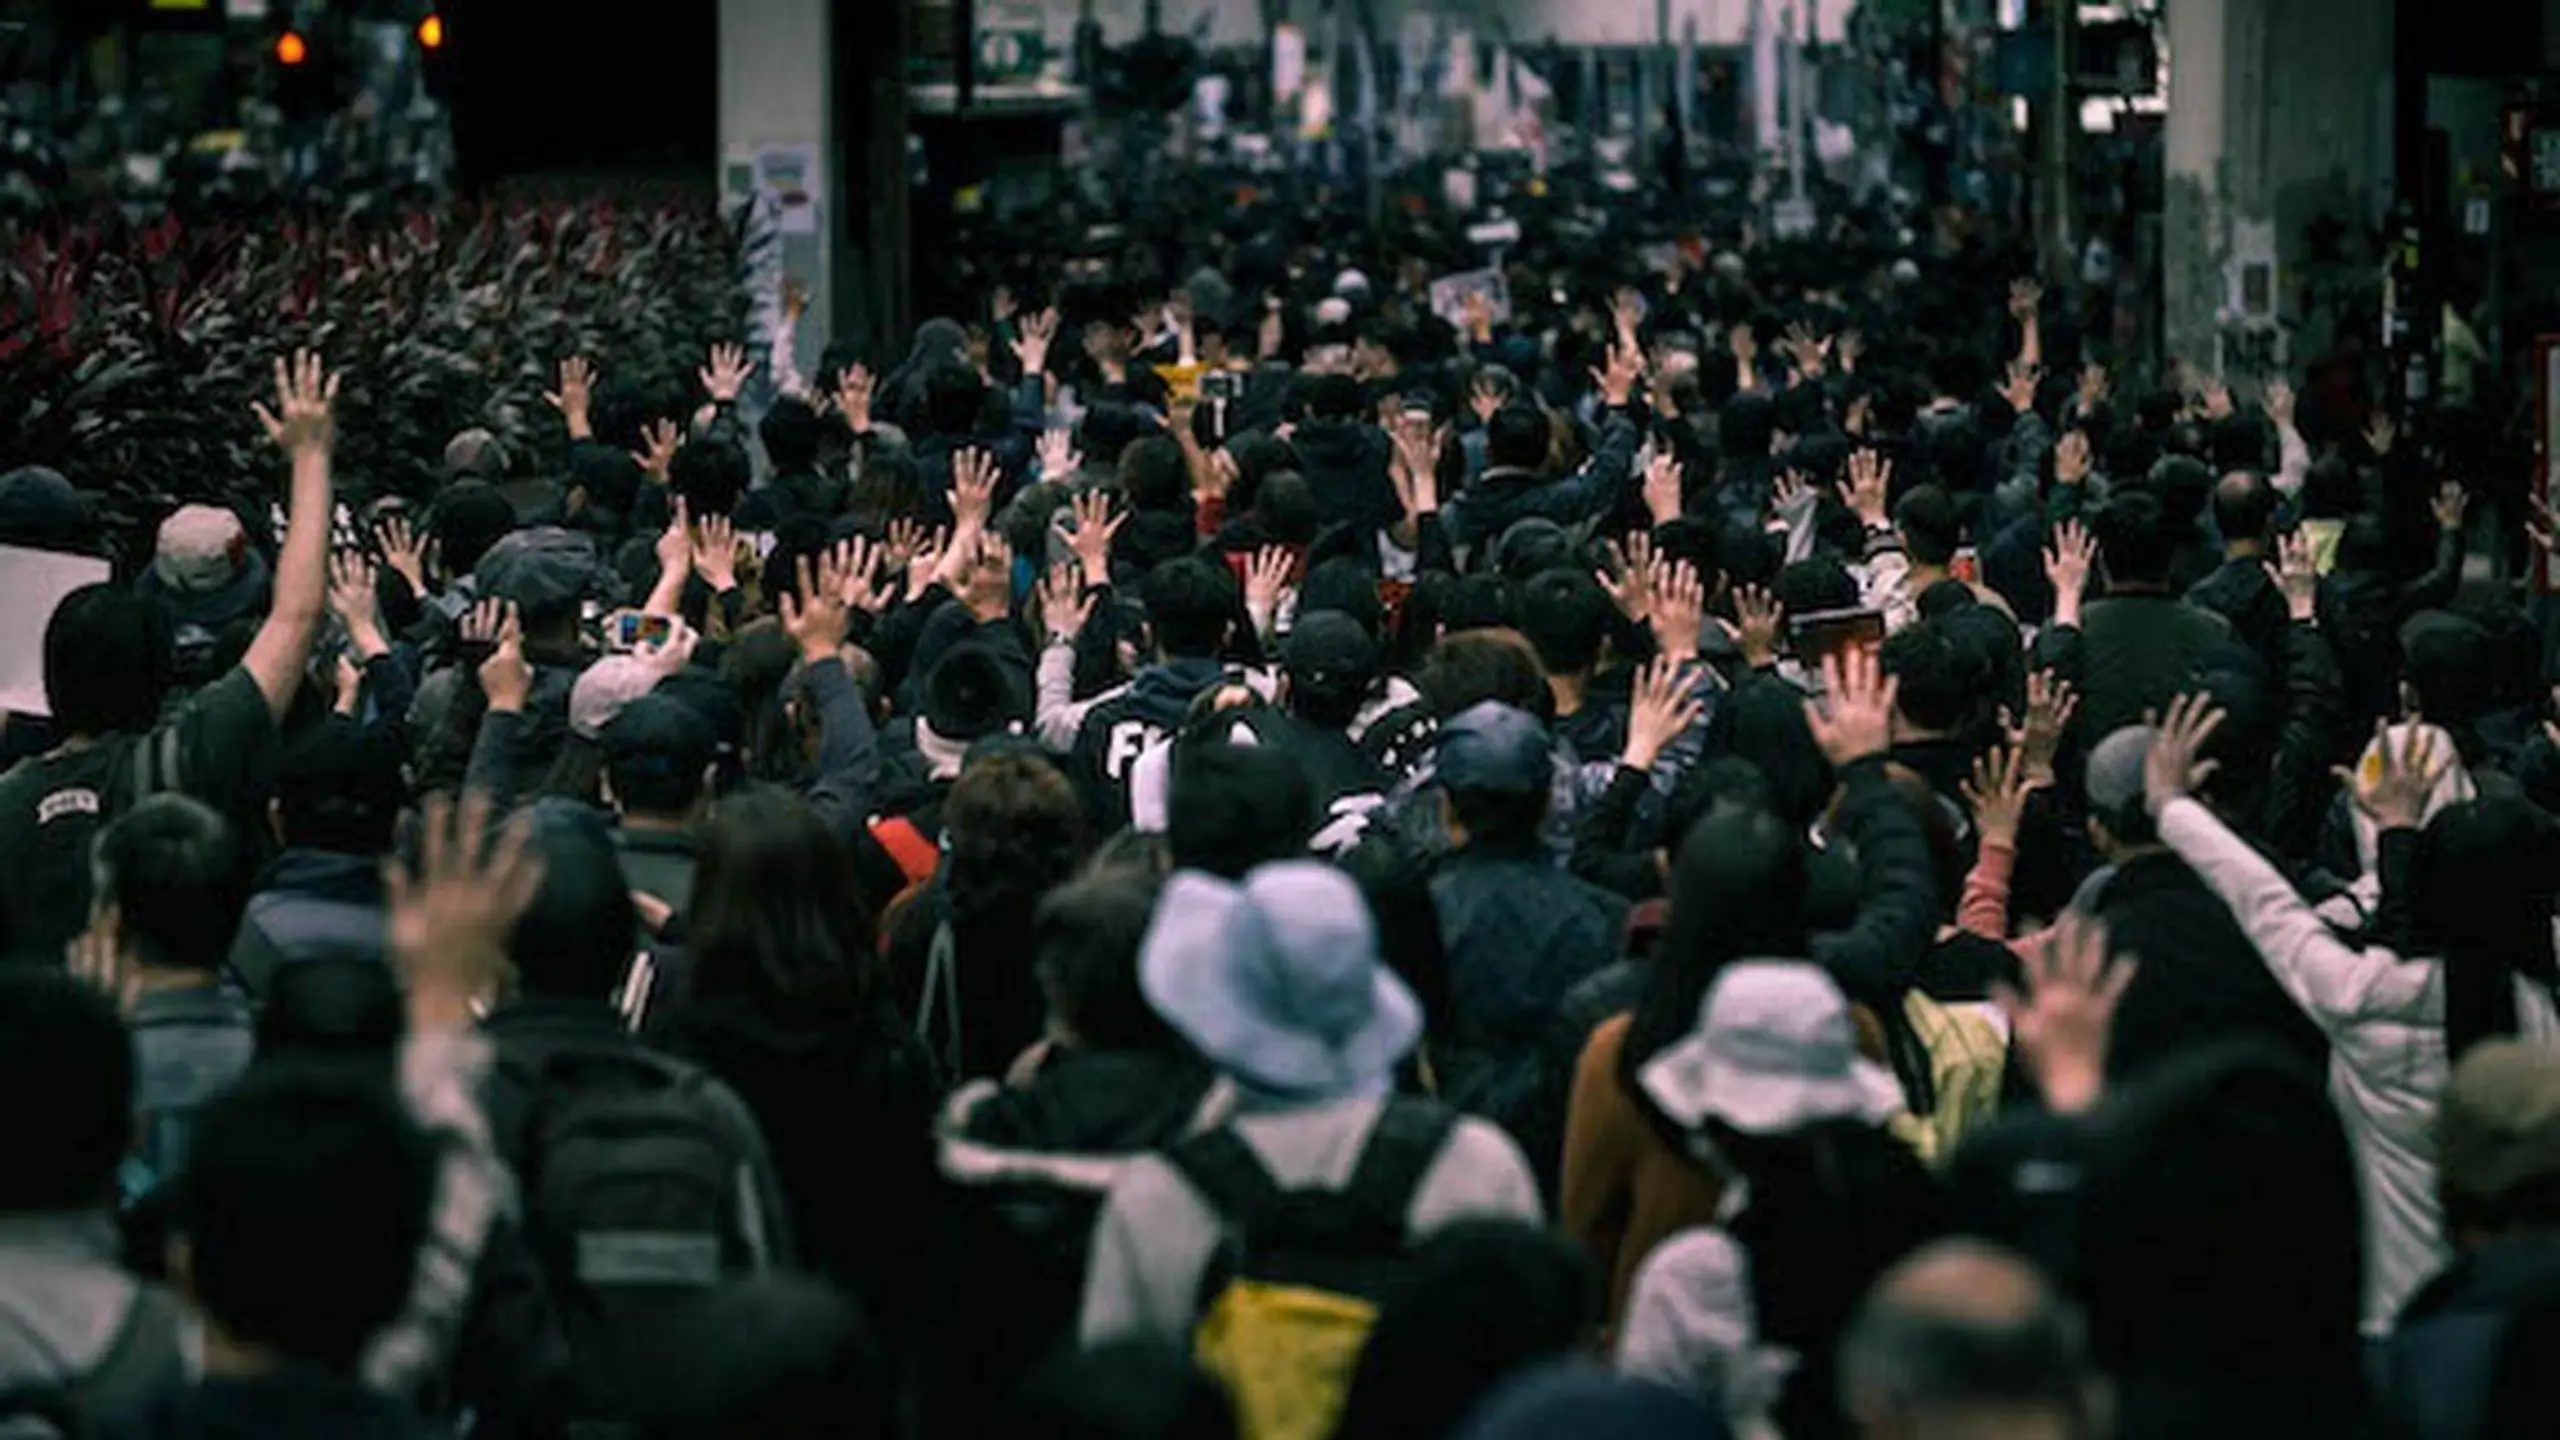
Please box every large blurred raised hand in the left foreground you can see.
[381,794,543,1027]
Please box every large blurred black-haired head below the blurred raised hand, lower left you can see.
[184,1063,435,1373]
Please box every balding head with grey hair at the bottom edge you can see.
[1841,1240,2112,1440]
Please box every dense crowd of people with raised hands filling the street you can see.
[0,179,2560,1440]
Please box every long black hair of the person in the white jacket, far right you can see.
[2414,797,2560,1063]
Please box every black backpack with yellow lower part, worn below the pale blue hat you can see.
[1165,1099,1457,1440]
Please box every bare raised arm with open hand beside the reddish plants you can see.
[241,351,338,720]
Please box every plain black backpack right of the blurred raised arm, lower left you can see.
[492,1040,778,1425]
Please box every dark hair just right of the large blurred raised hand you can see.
[507,799,640,999]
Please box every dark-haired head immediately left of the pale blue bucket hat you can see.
[1032,869,1183,1053]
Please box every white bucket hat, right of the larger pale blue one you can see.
[1641,961,1902,1135]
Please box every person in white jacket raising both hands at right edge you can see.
[2143,697,2560,1335]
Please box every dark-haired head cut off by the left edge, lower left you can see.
[0,969,133,1215]
